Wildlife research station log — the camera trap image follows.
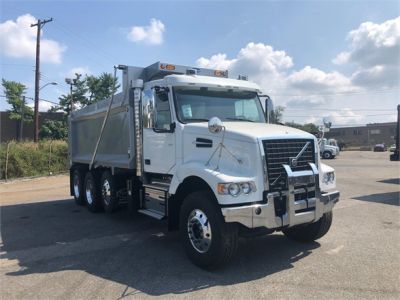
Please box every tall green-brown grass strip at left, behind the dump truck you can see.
[0,140,68,179]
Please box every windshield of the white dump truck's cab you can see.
[174,88,265,123]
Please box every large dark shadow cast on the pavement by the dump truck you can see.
[1,200,320,297]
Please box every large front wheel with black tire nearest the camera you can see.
[179,191,238,270]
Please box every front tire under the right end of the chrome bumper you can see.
[283,211,332,243]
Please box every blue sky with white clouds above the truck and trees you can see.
[0,0,400,127]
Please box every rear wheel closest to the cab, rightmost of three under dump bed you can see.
[100,171,118,214]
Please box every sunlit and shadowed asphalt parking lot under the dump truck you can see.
[0,152,400,299]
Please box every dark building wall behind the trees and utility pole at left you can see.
[0,111,65,142]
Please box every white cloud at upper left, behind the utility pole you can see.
[0,14,67,64]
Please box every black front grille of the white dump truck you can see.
[263,139,315,192]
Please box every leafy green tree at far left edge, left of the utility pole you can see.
[1,78,33,140]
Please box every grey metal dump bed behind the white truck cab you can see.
[69,93,135,169]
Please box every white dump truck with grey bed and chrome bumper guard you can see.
[69,62,339,269]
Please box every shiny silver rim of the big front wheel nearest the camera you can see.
[187,209,212,253]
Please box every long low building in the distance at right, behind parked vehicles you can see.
[325,122,396,147]
